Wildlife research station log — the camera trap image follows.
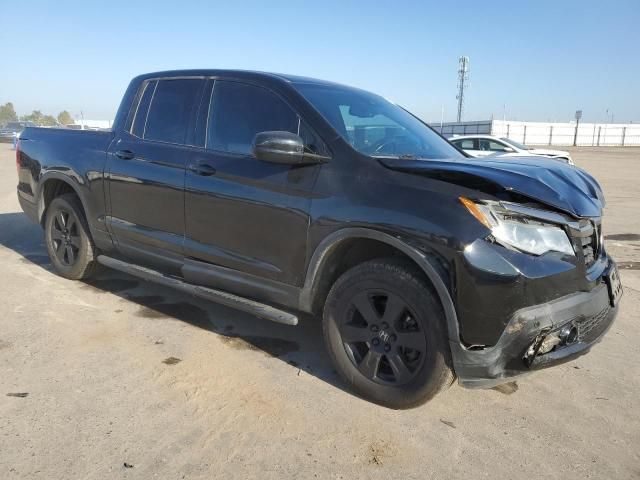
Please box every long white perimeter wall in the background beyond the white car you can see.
[431,120,640,147]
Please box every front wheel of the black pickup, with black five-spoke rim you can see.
[323,258,454,409]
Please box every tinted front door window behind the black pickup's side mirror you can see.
[207,80,298,154]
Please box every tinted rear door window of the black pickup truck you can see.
[142,78,204,144]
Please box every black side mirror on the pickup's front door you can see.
[251,131,328,165]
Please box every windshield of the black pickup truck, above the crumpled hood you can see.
[295,84,461,159]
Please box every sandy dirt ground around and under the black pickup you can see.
[0,145,640,480]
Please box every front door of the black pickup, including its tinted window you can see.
[185,80,325,289]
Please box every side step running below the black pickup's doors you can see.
[98,255,298,325]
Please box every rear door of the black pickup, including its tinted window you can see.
[107,78,205,270]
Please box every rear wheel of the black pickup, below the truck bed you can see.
[44,194,98,280]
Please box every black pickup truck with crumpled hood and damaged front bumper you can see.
[16,70,622,408]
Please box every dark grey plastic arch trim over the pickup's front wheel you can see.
[300,228,460,343]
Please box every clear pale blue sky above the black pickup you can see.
[0,0,640,122]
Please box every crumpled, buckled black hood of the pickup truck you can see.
[379,157,605,217]
